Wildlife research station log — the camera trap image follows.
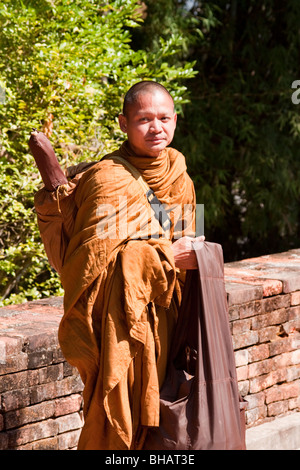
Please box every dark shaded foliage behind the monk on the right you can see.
[171,0,300,261]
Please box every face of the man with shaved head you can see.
[119,90,177,157]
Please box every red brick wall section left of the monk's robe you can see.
[0,298,83,450]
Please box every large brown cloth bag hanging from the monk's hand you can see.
[144,242,246,450]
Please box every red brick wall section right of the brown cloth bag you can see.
[225,250,300,426]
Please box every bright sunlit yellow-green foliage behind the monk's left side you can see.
[0,0,194,304]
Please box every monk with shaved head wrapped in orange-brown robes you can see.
[33,81,203,450]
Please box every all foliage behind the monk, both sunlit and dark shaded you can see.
[0,0,300,303]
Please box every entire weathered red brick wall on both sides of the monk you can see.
[0,250,300,450]
